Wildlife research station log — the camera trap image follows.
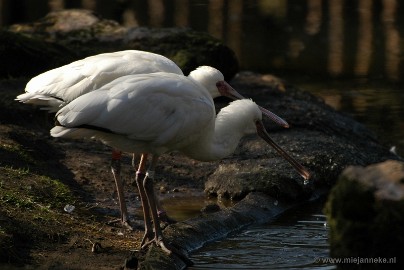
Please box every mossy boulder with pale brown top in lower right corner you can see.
[326,160,404,269]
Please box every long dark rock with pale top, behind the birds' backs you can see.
[4,10,238,79]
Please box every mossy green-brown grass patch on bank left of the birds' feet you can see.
[0,167,141,266]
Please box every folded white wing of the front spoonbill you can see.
[57,73,215,149]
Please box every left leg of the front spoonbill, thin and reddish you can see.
[135,154,153,247]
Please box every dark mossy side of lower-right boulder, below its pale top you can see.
[324,173,404,268]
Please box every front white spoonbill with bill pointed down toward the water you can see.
[51,69,310,253]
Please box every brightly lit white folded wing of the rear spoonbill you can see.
[17,50,183,107]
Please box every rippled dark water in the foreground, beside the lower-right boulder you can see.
[190,200,335,270]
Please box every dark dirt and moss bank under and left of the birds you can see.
[0,80,217,269]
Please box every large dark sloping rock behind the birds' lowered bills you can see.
[205,72,401,201]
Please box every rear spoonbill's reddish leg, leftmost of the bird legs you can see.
[111,149,133,230]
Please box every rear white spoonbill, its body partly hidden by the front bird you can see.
[16,50,288,228]
